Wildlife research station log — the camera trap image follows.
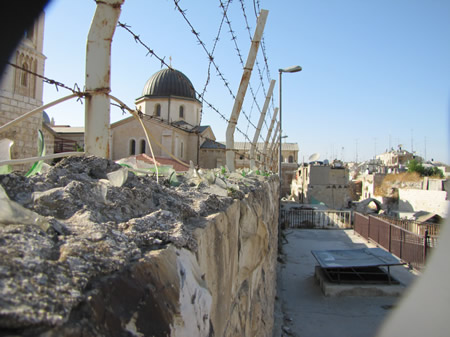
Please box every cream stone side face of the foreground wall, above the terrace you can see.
[134,176,278,337]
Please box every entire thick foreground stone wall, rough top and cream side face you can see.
[0,157,279,337]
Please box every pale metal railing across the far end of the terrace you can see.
[281,209,352,229]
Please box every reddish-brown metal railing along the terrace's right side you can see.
[354,212,437,270]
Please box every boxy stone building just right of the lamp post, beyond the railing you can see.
[292,161,350,209]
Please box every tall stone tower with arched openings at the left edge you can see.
[0,14,49,165]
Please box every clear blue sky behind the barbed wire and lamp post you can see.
[40,0,450,163]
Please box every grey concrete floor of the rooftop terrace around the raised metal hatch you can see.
[273,229,417,337]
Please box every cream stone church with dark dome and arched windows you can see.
[110,69,216,168]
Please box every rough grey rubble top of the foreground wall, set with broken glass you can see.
[0,157,274,335]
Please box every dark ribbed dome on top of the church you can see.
[142,68,196,99]
